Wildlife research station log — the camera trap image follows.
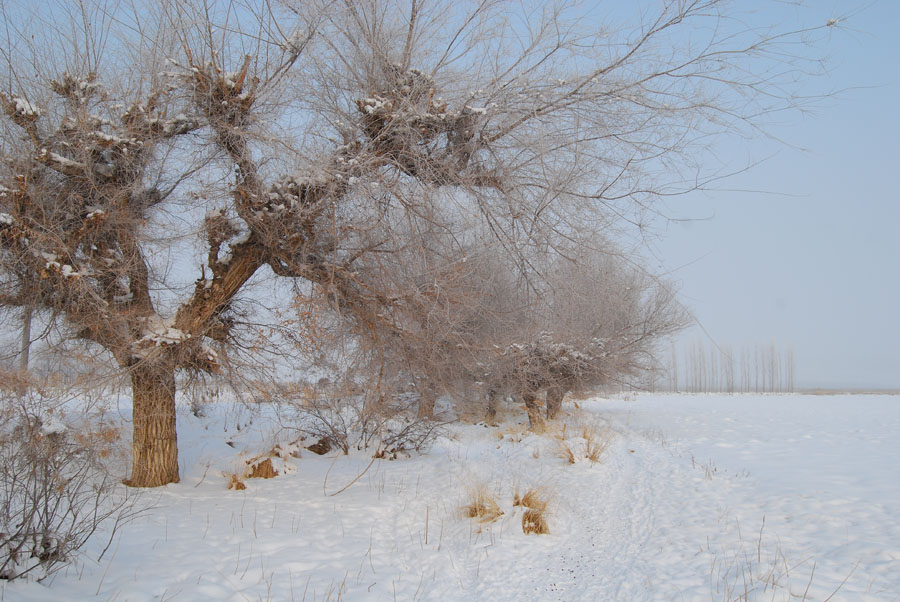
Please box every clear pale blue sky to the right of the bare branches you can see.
[651,0,900,389]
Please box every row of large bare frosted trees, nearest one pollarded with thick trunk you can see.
[0,0,829,487]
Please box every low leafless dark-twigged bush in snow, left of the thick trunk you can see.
[0,397,137,580]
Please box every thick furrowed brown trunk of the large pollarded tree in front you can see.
[125,363,178,487]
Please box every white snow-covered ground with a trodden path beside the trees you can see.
[0,395,900,602]
